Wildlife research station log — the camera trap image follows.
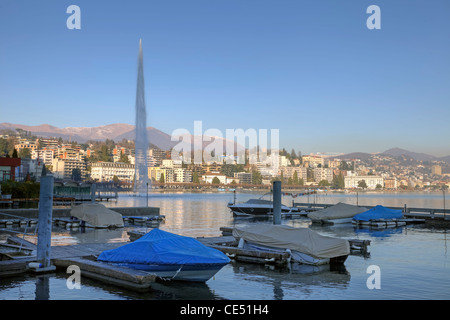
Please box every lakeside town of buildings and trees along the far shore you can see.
[0,129,450,191]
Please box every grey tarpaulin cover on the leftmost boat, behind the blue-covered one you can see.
[70,203,123,228]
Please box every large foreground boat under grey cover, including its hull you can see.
[233,224,350,265]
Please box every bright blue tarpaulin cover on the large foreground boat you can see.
[98,229,230,265]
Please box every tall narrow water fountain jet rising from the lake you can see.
[134,39,149,193]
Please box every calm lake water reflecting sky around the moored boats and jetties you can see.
[0,192,450,300]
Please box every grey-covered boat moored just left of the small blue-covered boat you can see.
[308,202,367,224]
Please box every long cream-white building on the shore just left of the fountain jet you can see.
[91,161,134,182]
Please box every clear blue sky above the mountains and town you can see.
[0,0,450,156]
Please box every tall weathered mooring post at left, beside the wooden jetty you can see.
[35,166,56,272]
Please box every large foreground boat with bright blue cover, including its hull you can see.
[97,229,230,282]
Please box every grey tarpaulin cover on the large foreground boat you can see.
[233,224,350,259]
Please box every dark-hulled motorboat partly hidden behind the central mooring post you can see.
[227,193,298,217]
